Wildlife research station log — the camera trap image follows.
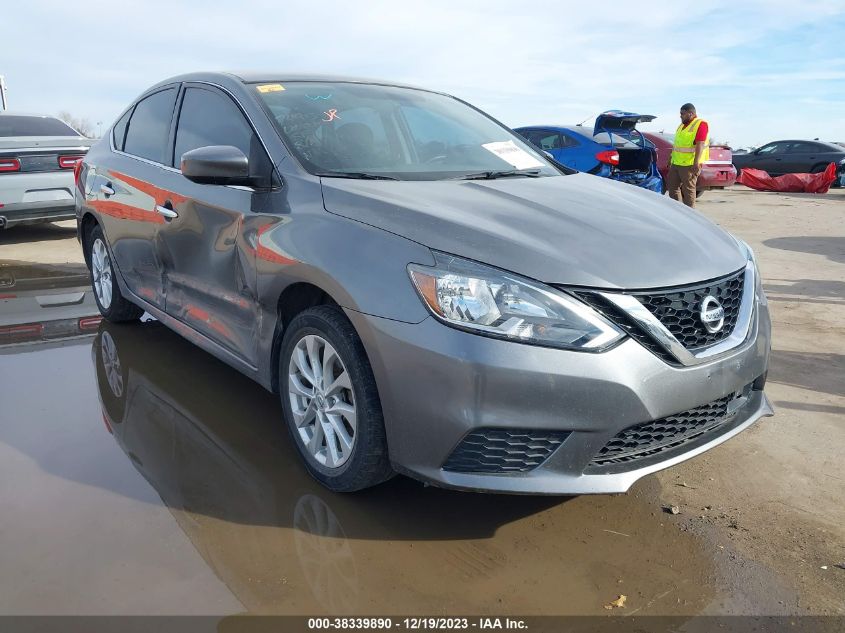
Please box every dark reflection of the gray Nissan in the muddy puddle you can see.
[92,322,561,613]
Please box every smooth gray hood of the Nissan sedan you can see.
[322,174,746,289]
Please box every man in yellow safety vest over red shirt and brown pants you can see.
[666,103,710,207]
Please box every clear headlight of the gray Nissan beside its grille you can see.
[408,253,625,352]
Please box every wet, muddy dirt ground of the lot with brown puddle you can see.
[0,187,845,615]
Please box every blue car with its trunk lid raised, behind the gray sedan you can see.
[515,110,664,193]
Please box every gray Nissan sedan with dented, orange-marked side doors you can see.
[75,73,772,494]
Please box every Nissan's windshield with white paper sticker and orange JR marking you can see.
[255,81,561,180]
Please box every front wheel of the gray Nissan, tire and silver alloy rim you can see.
[278,306,395,492]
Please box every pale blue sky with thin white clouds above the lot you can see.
[6,0,845,147]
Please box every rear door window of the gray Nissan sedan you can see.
[123,88,176,164]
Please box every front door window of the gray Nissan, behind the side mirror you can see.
[172,87,255,167]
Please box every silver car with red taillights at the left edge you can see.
[0,112,93,229]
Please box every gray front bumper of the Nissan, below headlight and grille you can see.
[347,296,772,494]
